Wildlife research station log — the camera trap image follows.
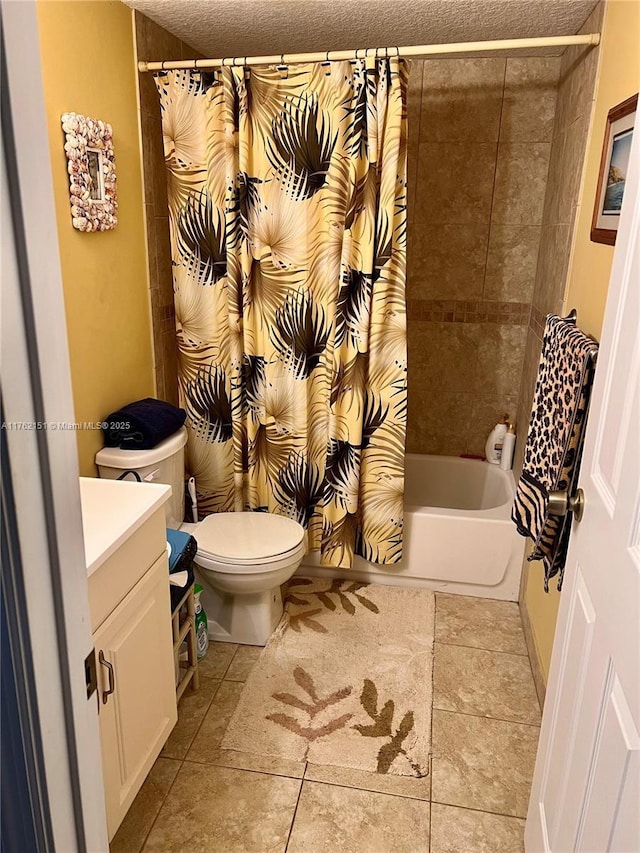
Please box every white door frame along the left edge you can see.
[0,0,108,853]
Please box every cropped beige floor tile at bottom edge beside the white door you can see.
[431,803,524,853]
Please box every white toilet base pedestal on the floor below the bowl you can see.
[200,584,283,646]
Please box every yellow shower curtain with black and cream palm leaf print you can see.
[156,58,408,567]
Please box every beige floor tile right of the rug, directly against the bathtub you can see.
[436,593,527,655]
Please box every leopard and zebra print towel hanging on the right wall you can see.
[511,314,597,592]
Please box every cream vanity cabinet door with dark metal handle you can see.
[93,555,177,840]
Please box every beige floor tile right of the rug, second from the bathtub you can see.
[433,643,540,725]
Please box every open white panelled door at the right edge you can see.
[525,121,640,853]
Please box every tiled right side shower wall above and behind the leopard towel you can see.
[514,3,604,471]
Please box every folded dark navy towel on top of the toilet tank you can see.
[102,397,187,450]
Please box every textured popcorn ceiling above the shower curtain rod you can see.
[124,0,596,59]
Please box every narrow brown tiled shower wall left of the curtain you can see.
[134,11,200,405]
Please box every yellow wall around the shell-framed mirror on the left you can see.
[37,0,154,476]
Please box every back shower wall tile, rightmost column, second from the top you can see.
[491,142,551,225]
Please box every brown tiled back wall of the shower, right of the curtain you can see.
[407,57,561,455]
